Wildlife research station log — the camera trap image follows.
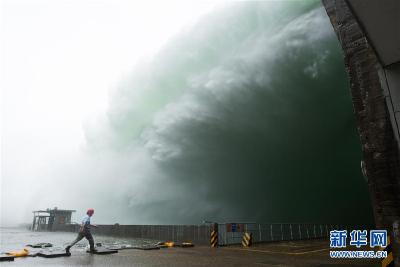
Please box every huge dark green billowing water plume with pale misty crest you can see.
[73,1,371,223]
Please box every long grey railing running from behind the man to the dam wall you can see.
[55,223,372,246]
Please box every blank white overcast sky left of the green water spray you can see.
[0,0,222,226]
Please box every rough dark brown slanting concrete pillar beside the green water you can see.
[322,0,400,261]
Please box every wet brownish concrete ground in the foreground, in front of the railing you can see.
[0,240,379,266]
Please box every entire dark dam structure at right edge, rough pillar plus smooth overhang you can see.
[322,0,400,264]
